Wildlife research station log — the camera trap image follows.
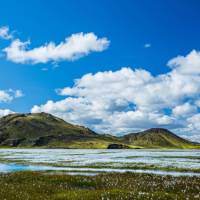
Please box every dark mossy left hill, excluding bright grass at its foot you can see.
[0,113,108,146]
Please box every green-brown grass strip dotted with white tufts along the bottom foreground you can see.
[0,172,200,200]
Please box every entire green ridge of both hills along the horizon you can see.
[0,113,200,148]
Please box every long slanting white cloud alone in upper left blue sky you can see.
[4,33,110,64]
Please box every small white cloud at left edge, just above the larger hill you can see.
[0,89,23,103]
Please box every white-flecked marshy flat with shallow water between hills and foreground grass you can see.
[0,149,200,176]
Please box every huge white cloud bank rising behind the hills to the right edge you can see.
[31,51,200,139]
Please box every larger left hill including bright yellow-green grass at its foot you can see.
[0,113,126,148]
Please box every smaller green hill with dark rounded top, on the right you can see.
[124,128,200,148]
